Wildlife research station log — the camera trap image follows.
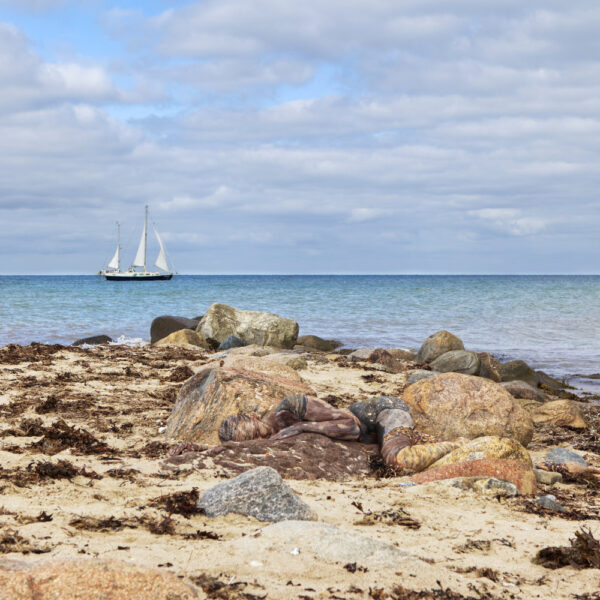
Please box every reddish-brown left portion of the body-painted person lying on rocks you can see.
[219,394,360,442]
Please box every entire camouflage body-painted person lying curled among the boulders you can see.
[219,394,465,475]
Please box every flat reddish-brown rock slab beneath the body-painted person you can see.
[200,433,379,481]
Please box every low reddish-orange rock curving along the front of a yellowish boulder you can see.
[410,459,536,495]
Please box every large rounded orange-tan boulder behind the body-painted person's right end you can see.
[403,373,533,446]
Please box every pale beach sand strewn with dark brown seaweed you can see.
[0,345,600,599]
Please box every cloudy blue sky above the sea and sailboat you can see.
[0,0,600,274]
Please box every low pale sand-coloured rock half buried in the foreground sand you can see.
[249,521,414,569]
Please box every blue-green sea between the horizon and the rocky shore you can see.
[0,275,600,393]
